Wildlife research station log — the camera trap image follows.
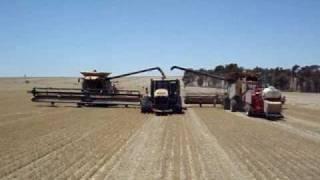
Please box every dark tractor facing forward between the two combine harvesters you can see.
[141,79,183,114]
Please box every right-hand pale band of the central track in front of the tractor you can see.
[186,109,250,179]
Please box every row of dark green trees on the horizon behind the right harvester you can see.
[183,63,320,93]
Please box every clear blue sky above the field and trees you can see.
[0,0,320,76]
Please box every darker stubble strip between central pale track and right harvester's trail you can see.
[196,109,320,179]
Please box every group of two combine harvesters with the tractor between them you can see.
[29,66,282,119]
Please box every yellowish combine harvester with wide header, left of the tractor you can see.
[29,67,165,107]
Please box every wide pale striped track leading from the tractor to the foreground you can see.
[90,110,248,179]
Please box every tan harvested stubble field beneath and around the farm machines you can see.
[0,77,320,180]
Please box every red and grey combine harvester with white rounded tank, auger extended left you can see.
[171,66,283,119]
